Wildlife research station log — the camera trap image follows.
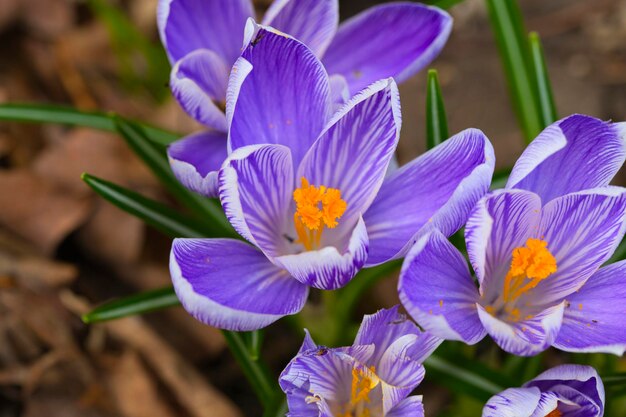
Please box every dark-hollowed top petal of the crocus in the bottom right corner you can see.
[524,365,604,417]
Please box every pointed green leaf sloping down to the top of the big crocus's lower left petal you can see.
[81,174,211,238]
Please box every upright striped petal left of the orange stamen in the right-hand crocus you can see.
[465,190,541,290]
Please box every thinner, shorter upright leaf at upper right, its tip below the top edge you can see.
[528,32,558,128]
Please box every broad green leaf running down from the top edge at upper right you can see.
[486,0,542,143]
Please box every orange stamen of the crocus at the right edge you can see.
[502,238,557,302]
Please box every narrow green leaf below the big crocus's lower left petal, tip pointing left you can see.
[82,287,180,324]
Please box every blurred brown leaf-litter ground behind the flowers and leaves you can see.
[0,0,626,417]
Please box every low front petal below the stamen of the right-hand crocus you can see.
[477,302,565,356]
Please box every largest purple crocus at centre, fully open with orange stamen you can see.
[170,27,494,330]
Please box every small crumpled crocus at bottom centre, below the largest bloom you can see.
[279,306,441,417]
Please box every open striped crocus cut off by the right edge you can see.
[399,115,626,355]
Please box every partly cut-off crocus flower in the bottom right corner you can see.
[483,365,604,417]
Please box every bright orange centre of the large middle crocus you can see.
[293,177,348,250]
